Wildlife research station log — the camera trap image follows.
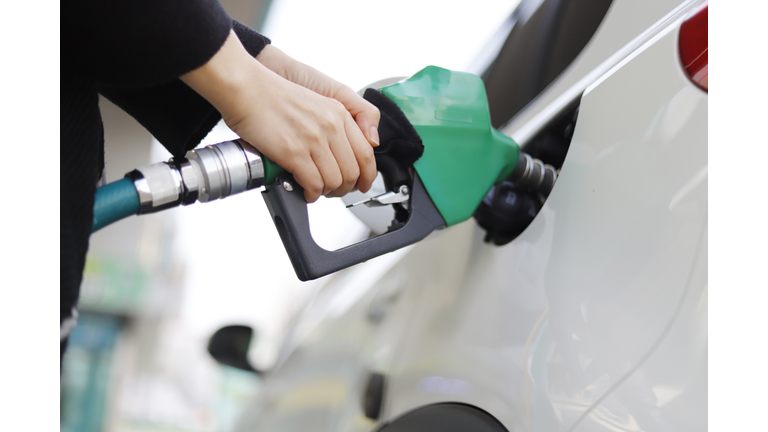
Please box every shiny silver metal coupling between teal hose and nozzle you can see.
[126,139,264,214]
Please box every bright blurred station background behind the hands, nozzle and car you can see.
[61,0,518,432]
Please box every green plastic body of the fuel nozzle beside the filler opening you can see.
[380,66,520,226]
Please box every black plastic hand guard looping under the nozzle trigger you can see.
[261,172,445,281]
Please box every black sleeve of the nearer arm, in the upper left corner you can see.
[60,0,232,87]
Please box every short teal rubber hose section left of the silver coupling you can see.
[91,177,140,233]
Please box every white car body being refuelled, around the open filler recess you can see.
[235,0,708,432]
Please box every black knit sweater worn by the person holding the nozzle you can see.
[59,0,269,342]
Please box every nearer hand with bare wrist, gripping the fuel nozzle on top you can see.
[181,32,378,202]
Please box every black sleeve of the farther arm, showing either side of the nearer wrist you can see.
[99,21,270,158]
